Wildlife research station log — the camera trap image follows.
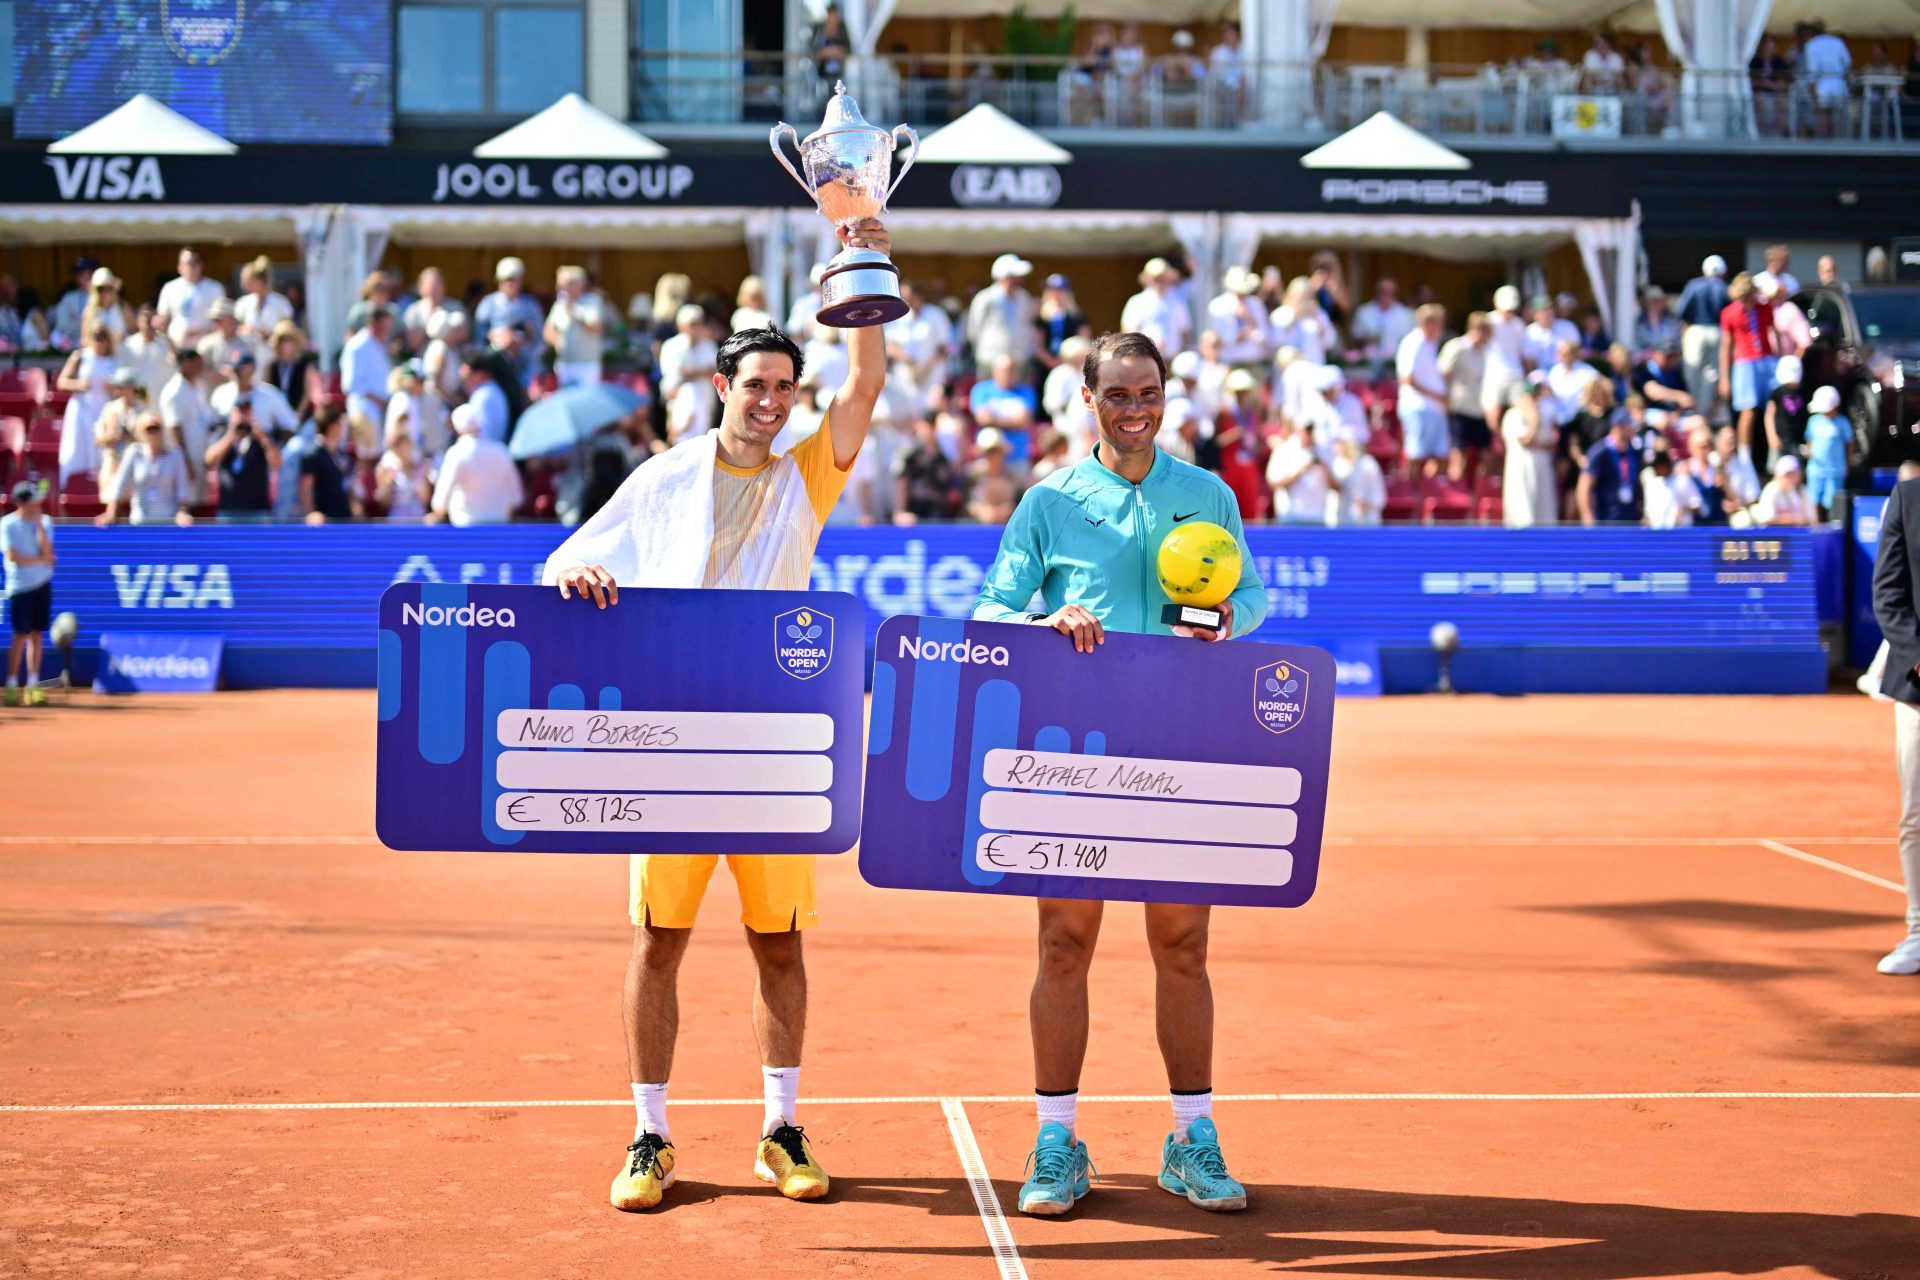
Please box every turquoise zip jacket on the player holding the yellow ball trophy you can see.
[973,445,1267,635]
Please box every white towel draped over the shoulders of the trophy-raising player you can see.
[543,432,808,589]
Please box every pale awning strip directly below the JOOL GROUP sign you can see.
[378,205,748,249]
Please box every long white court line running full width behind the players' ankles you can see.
[0,1090,1920,1115]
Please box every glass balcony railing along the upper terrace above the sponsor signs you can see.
[634,50,1920,146]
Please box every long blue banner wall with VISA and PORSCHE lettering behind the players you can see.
[37,524,1826,693]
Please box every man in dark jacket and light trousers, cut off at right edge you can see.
[1874,477,1920,975]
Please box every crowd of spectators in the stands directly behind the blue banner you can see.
[0,235,1855,528]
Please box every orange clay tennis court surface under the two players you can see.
[0,693,1920,1280]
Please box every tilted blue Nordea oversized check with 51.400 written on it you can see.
[860,618,1334,906]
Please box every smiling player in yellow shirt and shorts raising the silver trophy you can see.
[547,219,891,1211]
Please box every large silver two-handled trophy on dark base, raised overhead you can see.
[766,83,920,328]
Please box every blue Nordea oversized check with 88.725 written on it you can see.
[374,583,866,854]
